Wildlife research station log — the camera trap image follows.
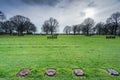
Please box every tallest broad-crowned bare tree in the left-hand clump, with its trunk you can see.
[10,15,30,35]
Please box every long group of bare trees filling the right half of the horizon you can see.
[63,12,120,35]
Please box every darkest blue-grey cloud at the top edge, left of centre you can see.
[22,0,60,6]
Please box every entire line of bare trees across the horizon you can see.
[0,11,120,35]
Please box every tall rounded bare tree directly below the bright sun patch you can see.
[82,18,95,35]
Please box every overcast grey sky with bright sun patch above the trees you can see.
[0,0,120,32]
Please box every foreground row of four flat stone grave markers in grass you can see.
[17,68,119,77]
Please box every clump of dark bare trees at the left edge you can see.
[0,11,36,35]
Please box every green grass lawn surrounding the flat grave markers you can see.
[0,35,120,80]
